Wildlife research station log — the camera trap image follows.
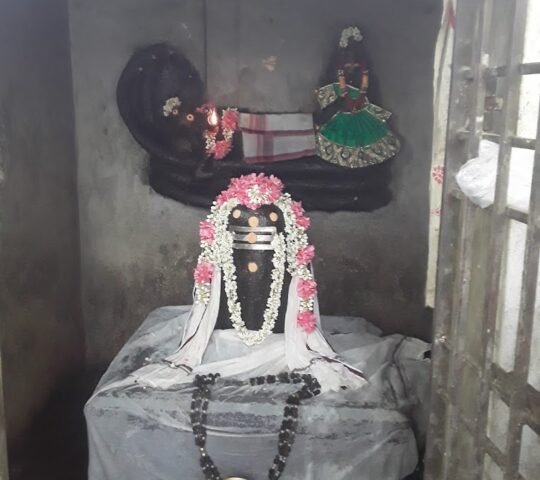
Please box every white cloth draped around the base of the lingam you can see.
[119,270,366,392]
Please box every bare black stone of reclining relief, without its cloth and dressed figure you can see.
[117,44,392,211]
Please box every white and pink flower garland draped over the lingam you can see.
[194,174,317,345]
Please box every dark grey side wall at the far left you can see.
[0,0,84,439]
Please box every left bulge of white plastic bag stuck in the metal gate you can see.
[456,140,499,208]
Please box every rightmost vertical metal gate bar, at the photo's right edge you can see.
[505,93,540,480]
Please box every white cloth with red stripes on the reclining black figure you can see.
[239,113,315,163]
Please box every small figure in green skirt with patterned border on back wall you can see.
[317,27,400,168]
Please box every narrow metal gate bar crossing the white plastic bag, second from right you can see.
[476,0,527,478]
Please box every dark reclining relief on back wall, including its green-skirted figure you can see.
[117,27,399,211]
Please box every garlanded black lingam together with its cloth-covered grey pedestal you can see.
[85,174,430,480]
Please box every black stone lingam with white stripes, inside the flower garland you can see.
[216,205,291,333]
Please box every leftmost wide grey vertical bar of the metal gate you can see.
[425,0,483,480]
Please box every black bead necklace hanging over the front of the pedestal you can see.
[190,372,321,480]
